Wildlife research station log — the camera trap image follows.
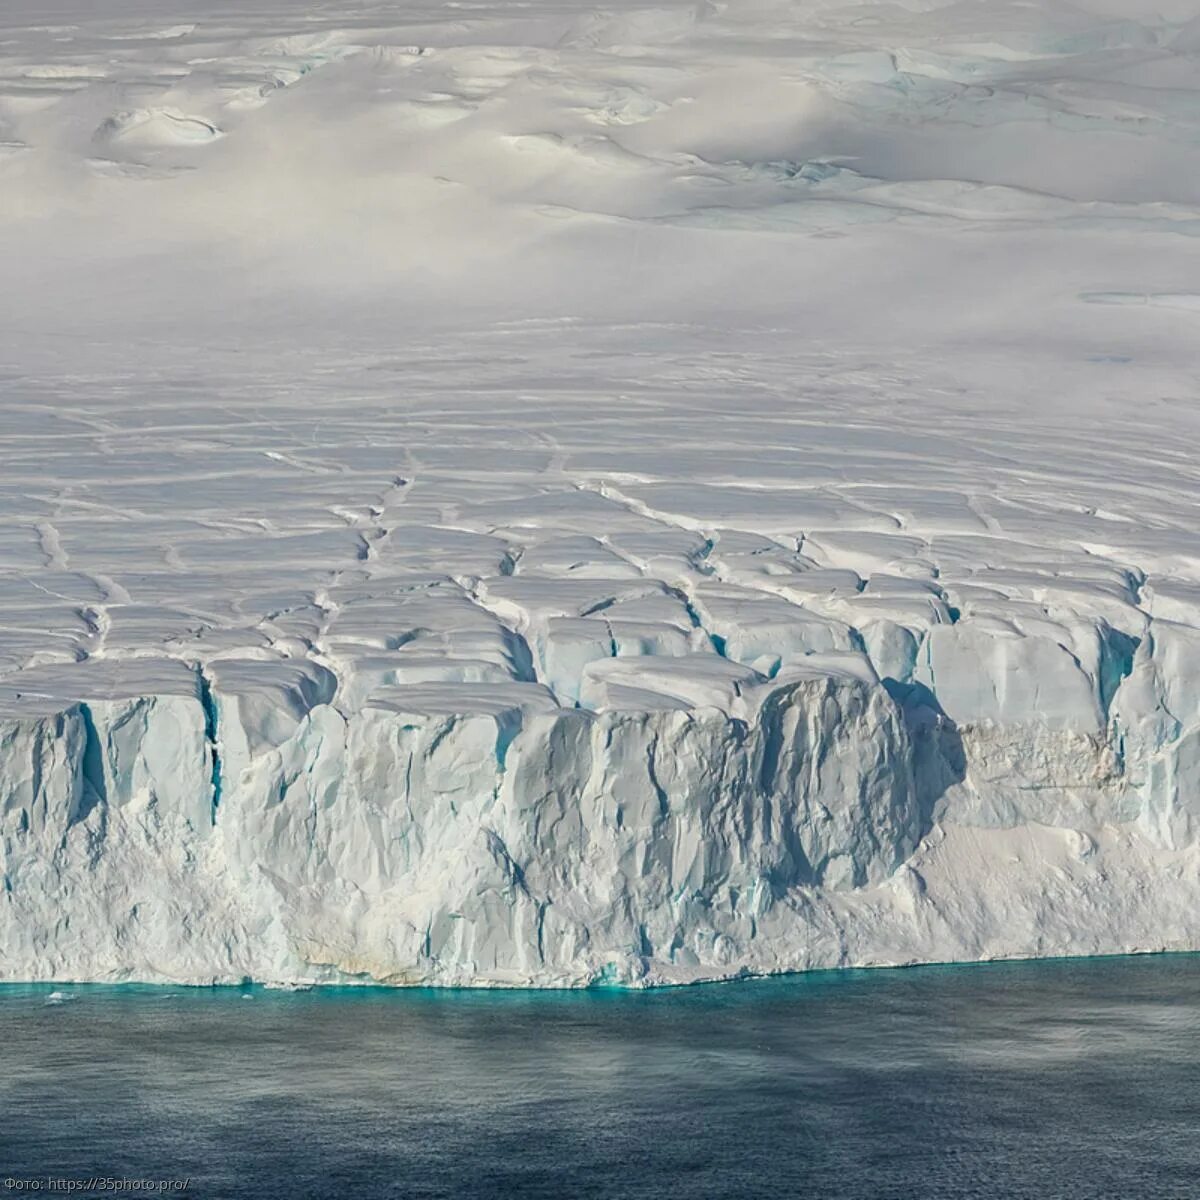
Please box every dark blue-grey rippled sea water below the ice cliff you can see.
[0,956,1200,1200]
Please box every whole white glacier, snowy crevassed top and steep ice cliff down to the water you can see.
[0,0,1200,985]
